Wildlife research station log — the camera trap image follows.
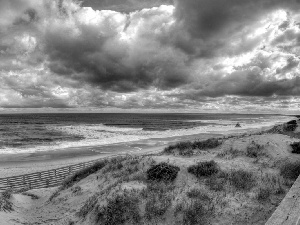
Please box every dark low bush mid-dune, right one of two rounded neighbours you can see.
[188,160,220,178]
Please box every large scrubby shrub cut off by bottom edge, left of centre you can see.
[96,195,141,225]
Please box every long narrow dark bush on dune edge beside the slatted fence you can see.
[61,161,107,190]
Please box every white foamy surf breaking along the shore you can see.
[0,116,291,154]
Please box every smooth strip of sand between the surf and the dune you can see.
[0,121,282,178]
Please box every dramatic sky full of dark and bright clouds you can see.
[0,0,300,114]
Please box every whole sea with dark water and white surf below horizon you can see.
[0,113,294,154]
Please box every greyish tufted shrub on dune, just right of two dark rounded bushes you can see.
[228,169,256,190]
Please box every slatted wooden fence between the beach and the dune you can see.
[0,159,103,192]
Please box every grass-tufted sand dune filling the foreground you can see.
[2,123,299,225]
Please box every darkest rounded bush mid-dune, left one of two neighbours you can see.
[147,162,180,182]
